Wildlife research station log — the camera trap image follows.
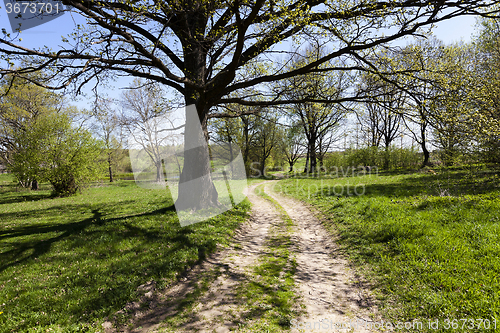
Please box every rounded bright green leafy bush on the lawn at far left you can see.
[10,112,102,196]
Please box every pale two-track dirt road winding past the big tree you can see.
[104,181,380,333]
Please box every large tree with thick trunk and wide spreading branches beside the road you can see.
[0,0,500,208]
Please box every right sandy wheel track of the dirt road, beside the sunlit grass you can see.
[268,183,380,332]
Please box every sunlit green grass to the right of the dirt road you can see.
[276,169,500,332]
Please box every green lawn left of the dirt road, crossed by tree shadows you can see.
[0,175,249,332]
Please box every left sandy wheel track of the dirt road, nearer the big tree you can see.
[105,184,280,333]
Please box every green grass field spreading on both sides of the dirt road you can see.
[0,167,500,332]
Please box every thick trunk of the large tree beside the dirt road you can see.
[173,25,219,210]
